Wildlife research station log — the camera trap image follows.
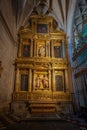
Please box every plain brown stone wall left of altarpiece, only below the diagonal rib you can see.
[0,22,17,112]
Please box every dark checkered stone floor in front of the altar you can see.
[0,113,87,130]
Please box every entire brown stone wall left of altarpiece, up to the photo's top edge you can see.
[0,0,18,112]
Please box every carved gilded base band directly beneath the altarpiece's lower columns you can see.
[13,92,71,101]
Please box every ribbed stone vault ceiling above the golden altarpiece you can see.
[0,0,77,43]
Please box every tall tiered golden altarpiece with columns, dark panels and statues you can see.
[13,15,72,113]
